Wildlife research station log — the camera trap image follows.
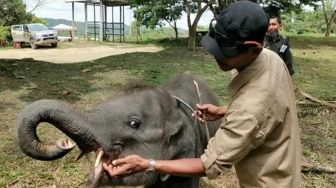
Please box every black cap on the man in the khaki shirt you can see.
[201,1,269,59]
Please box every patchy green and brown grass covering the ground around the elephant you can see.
[0,37,336,187]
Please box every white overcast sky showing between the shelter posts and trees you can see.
[34,0,213,29]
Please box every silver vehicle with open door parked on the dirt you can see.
[11,23,58,49]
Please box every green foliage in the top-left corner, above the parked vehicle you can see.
[0,0,33,26]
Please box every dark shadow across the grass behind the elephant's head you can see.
[0,48,228,108]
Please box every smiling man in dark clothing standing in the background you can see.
[264,16,294,75]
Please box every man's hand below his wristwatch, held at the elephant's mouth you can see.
[103,155,150,177]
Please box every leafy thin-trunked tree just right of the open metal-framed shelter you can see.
[134,0,183,39]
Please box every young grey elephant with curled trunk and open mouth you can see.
[17,73,221,188]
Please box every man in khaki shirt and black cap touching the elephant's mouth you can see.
[103,1,301,188]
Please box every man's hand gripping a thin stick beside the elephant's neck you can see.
[193,104,227,122]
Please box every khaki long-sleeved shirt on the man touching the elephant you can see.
[201,49,301,187]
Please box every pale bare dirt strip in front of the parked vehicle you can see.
[0,44,162,63]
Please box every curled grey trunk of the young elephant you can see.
[18,100,96,160]
